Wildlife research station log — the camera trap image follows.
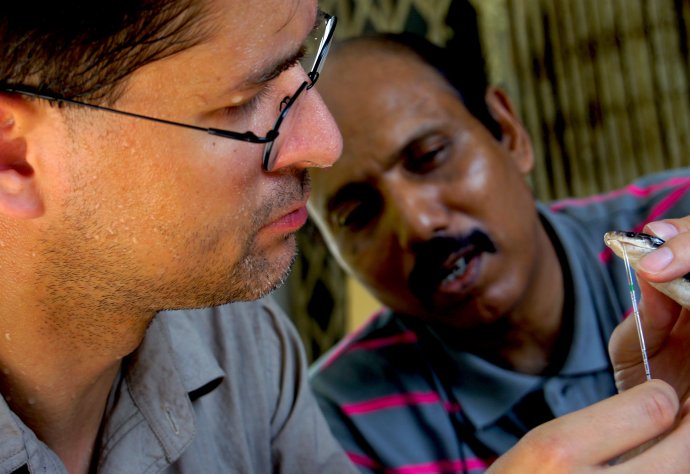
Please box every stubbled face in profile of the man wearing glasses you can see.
[32,0,341,310]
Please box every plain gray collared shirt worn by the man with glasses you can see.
[0,300,354,474]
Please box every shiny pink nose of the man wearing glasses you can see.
[272,67,343,171]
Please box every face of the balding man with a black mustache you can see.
[310,47,539,327]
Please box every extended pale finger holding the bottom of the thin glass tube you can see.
[520,380,679,466]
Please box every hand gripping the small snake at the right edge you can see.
[609,217,690,402]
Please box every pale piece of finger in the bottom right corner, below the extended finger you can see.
[610,398,690,474]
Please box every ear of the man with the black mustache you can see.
[486,86,534,175]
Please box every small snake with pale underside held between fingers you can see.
[604,230,690,308]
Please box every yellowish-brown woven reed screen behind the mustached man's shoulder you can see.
[473,0,690,200]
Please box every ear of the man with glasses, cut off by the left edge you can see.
[0,93,44,219]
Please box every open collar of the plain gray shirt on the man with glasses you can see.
[0,310,225,472]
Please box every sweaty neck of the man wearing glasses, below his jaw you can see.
[0,223,160,473]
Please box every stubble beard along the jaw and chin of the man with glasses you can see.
[36,218,296,318]
